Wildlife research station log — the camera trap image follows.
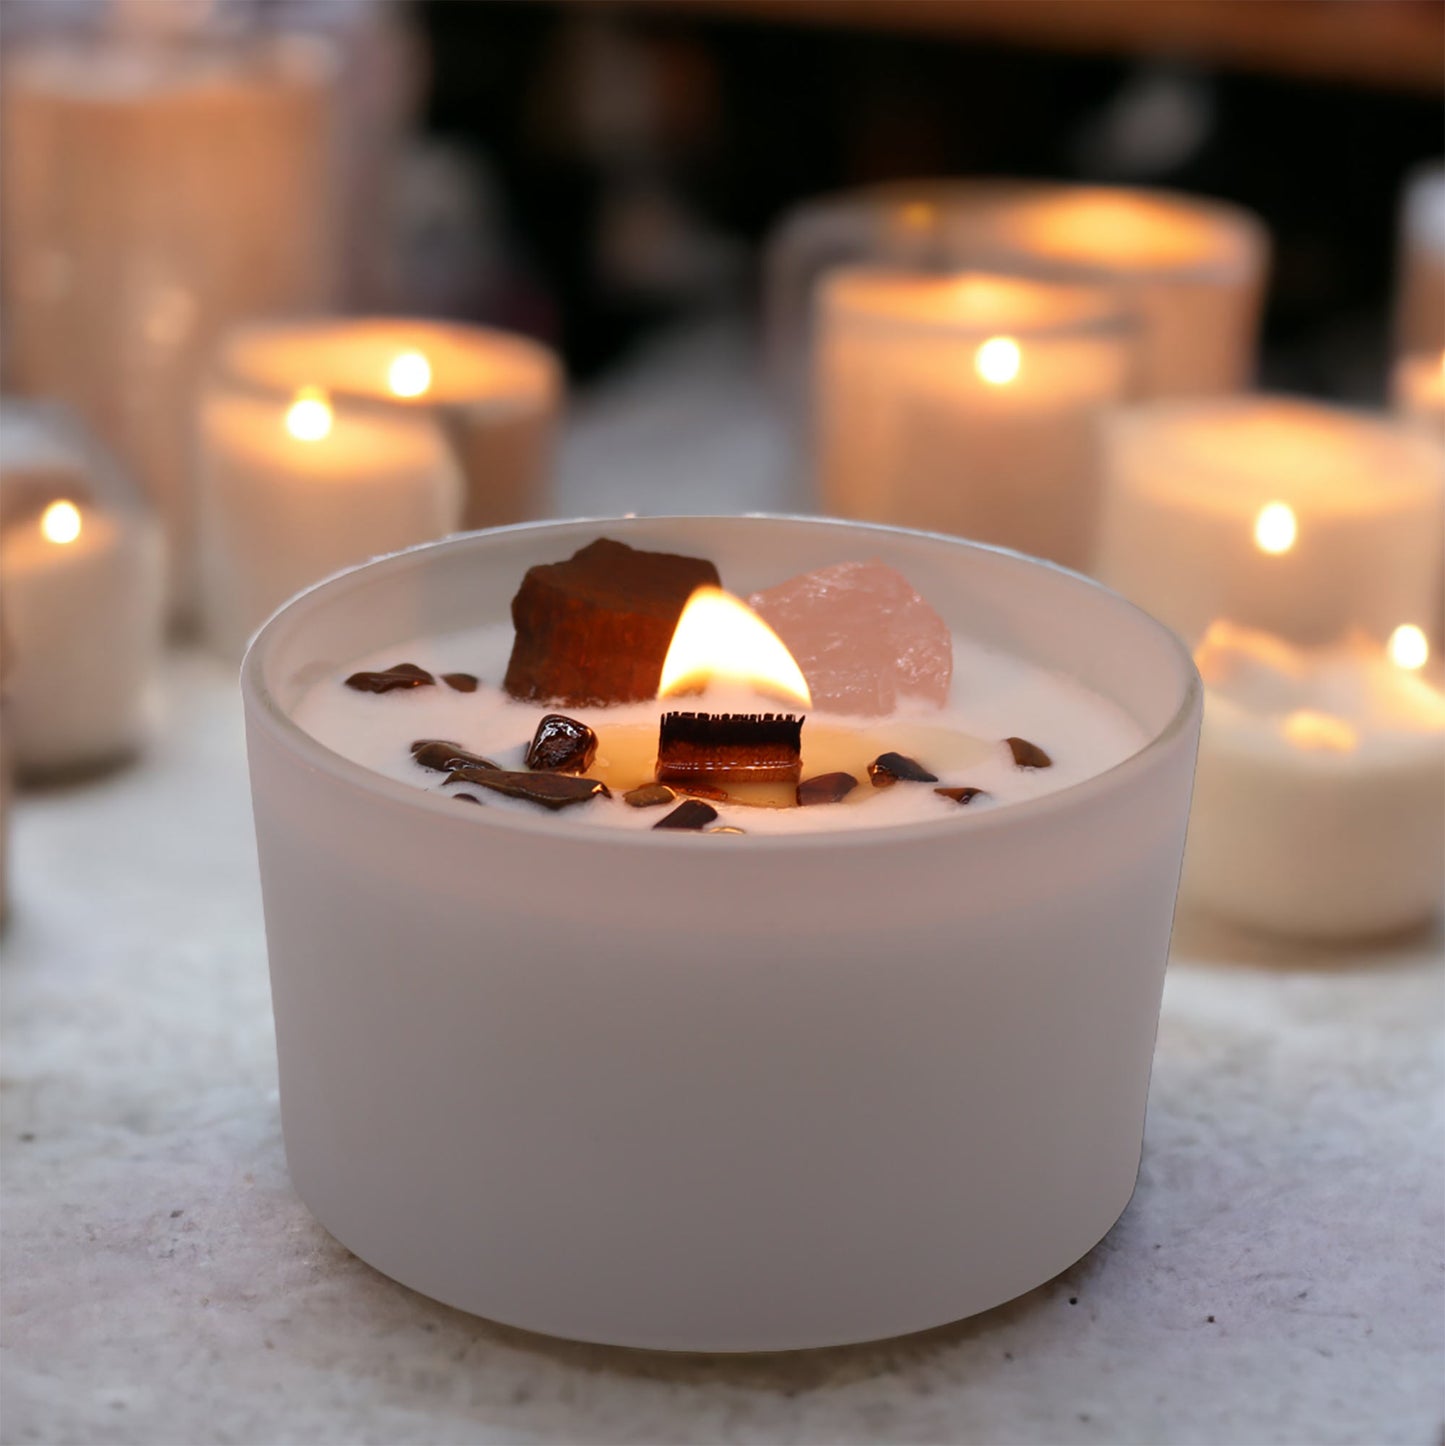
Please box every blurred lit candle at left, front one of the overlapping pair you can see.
[200,383,463,658]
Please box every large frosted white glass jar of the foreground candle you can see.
[242,518,1199,1351]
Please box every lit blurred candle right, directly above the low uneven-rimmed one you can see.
[1095,396,1445,643]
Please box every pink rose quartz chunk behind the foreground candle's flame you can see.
[748,561,953,716]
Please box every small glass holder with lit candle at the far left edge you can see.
[0,401,165,778]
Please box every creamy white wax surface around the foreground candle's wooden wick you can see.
[297,625,1143,834]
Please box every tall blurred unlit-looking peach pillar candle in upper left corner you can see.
[0,28,331,615]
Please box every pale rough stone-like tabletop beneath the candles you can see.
[0,322,1445,1446]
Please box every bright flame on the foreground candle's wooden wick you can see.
[657,587,813,709]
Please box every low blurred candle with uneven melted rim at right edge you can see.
[1183,623,1445,937]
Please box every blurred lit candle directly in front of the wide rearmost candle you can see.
[814,269,1134,567]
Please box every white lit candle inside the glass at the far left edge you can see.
[0,502,165,774]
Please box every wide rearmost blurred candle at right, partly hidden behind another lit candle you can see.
[764,179,1269,396]
